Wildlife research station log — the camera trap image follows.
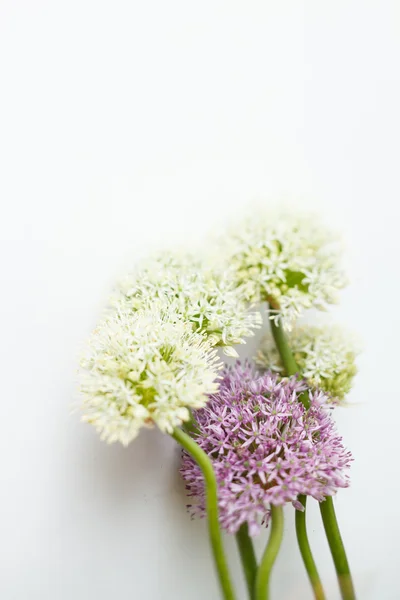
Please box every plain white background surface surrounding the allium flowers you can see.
[0,0,400,600]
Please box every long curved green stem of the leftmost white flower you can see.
[171,428,235,600]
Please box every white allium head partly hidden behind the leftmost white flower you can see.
[112,253,262,356]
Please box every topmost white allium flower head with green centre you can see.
[216,210,346,330]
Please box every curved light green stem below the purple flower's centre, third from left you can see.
[254,506,283,600]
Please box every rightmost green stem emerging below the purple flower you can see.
[319,496,356,600]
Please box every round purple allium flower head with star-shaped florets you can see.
[181,363,352,535]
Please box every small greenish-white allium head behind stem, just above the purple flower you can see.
[256,325,358,400]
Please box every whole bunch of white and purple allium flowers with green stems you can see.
[76,212,357,600]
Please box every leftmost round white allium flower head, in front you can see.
[81,302,220,445]
